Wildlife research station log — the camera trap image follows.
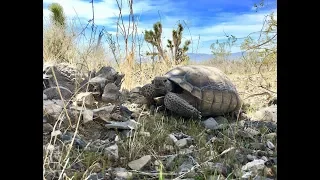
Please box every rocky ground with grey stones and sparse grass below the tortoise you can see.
[43,64,277,180]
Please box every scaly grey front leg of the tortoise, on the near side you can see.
[164,92,201,119]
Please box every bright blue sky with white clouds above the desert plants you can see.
[43,0,277,54]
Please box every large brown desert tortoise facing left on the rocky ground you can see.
[141,65,241,118]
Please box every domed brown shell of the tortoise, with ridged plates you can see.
[165,65,241,116]
